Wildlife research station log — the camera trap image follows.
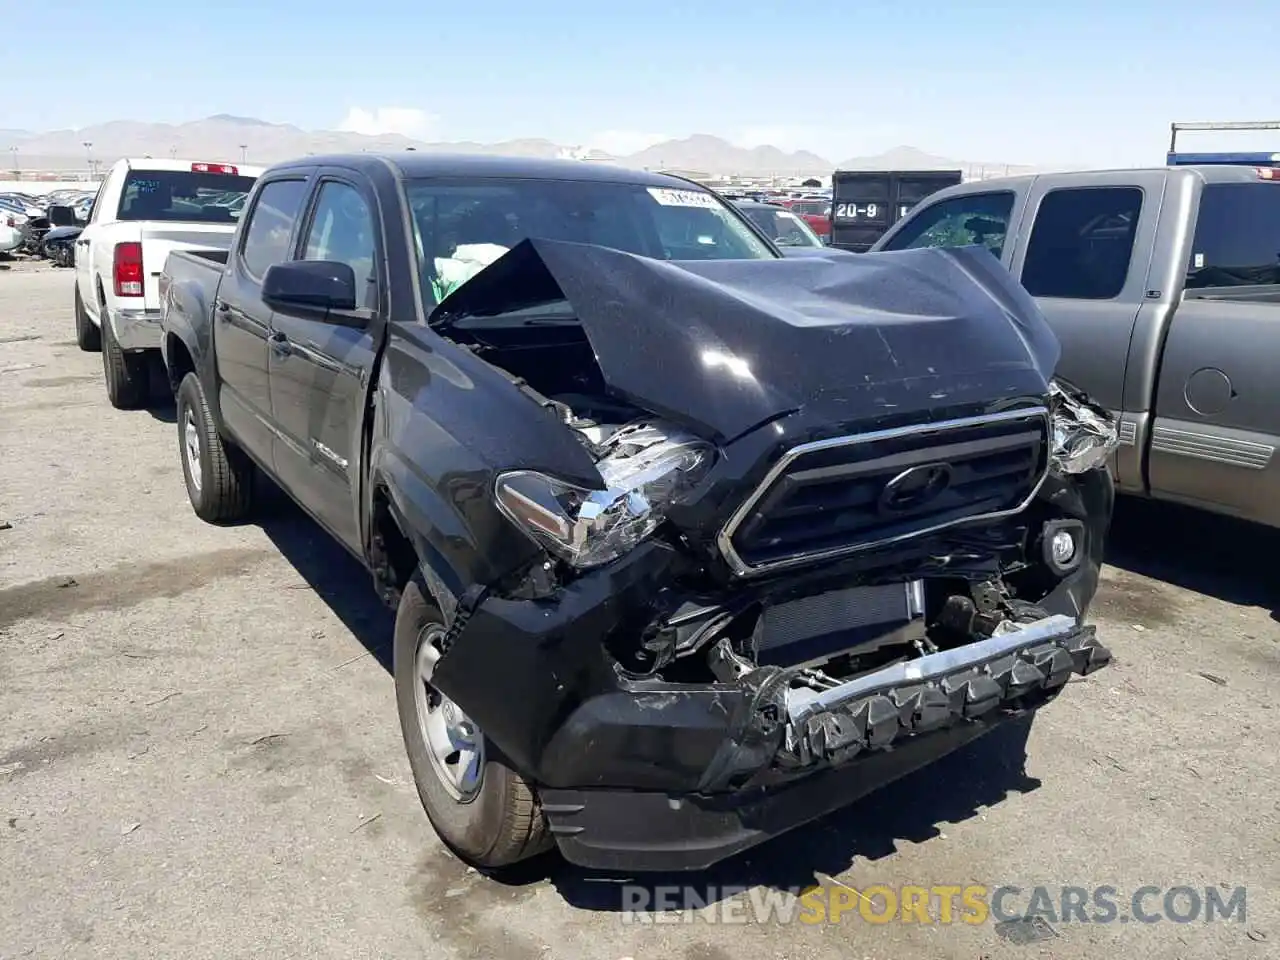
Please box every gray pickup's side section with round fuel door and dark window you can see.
[1148,180,1280,526]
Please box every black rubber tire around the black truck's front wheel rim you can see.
[393,579,552,870]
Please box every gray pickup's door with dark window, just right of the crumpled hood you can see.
[1011,170,1167,489]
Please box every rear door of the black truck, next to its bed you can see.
[214,177,308,465]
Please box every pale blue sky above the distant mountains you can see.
[0,0,1280,164]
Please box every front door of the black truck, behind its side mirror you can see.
[268,170,376,552]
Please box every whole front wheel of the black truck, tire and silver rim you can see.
[393,580,552,869]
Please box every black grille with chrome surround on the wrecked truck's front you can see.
[719,407,1050,575]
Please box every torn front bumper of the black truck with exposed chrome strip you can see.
[435,544,1111,869]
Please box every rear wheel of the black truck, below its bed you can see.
[177,374,253,524]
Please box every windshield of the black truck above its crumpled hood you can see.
[406,179,776,303]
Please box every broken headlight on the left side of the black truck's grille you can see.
[494,422,716,568]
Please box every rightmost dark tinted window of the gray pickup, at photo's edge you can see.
[1187,183,1280,288]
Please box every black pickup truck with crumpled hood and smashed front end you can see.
[163,154,1115,869]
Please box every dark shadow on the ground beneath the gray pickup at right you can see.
[1106,497,1280,620]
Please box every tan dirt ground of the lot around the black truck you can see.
[0,262,1280,960]
